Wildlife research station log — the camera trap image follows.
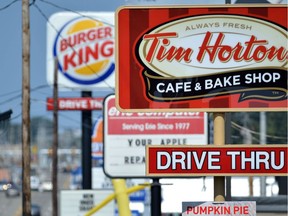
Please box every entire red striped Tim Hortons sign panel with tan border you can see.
[116,5,288,112]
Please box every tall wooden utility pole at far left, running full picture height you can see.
[22,0,31,216]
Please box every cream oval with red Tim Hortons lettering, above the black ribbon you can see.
[136,15,287,77]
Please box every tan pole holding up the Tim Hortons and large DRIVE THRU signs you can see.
[213,113,225,201]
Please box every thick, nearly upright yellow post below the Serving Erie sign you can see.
[112,179,131,216]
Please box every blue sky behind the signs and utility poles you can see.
[0,0,287,128]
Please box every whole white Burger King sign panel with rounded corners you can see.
[47,12,115,90]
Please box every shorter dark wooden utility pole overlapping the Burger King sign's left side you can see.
[52,58,58,216]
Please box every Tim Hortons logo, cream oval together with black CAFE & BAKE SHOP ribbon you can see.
[136,15,288,102]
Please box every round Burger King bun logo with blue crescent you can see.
[53,17,115,85]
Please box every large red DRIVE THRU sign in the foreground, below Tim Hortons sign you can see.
[146,145,288,177]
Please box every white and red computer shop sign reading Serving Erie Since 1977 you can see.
[104,95,208,177]
